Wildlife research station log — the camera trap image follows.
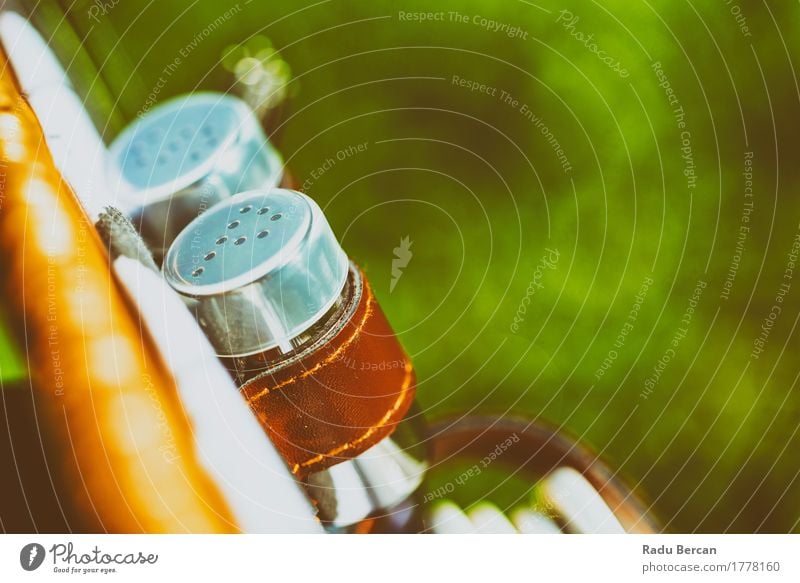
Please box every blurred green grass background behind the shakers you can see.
[10,0,800,532]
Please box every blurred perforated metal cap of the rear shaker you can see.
[108,93,283,258]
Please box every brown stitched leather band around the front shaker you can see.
[241,273,416,478]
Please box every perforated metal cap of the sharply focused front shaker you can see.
[162,188,349,356]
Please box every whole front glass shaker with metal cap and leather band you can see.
[163,189,427,530]
